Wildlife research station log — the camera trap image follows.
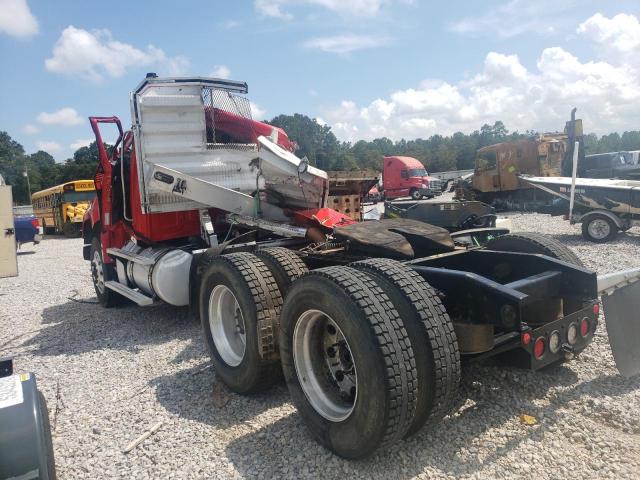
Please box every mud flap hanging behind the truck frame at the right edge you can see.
[602,274,640,377]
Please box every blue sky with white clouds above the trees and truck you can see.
[0,0,640,161]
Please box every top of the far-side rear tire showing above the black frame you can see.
[486,232,584,267]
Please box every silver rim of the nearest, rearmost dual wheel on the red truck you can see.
[293,310,358,422]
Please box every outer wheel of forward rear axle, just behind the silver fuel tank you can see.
[199,252,282,394]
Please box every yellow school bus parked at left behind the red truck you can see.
[31,180,96,237]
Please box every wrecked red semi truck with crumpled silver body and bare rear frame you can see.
[83,75,640,458]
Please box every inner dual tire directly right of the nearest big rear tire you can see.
[350,259,460,436]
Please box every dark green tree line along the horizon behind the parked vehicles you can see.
[0,113,640,204]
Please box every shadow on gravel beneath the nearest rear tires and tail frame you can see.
[221,365,640,478]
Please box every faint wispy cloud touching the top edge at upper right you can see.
[449,0,581,38]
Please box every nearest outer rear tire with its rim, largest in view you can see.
[280,266,418,459]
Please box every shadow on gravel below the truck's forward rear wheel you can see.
[151,362,289,428]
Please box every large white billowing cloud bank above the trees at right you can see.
[320,16,640,141]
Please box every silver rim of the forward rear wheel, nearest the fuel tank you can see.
[209,285,247,367]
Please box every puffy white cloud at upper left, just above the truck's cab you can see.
[45,25,189,81]
